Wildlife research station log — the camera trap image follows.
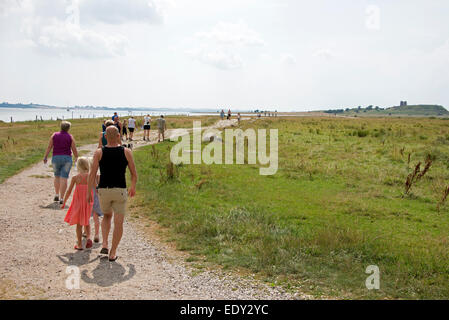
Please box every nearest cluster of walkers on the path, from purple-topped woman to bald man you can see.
[44,114,141,261]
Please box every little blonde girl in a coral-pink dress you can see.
[61,157,93,250]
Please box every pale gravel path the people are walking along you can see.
[0,121,307,299]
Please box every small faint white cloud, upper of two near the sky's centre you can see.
[196,21,265,46]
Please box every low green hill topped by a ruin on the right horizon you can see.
[324,104,449,117]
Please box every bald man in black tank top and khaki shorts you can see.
[87,126,137,261]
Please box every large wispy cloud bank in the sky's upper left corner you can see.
[10,0,147,58]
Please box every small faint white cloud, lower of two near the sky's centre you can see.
[186,48,243,70]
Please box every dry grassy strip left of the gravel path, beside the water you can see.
[0,116,217,183]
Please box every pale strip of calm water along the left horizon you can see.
[0,108,218,122]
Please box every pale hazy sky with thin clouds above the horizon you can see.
[0,0,449,111]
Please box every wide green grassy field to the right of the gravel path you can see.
[133,118,449,299]
